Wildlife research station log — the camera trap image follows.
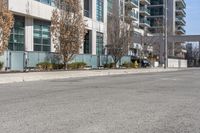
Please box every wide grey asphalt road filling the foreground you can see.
[0,69,200,133]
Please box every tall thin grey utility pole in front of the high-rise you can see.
[164,0,168,69]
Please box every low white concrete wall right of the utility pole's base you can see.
[168,59,188,68]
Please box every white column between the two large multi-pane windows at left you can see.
[25,17,34,51]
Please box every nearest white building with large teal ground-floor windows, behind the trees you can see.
[8,0,107,55]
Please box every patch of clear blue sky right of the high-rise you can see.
[185,0,200,35]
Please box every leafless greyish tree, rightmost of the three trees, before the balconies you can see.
[107,0,133,67]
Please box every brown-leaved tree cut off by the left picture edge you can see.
[0,0,14,54]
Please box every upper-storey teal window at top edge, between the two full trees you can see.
[96,0,104,22]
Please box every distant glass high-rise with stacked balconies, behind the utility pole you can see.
[148,0,186,56]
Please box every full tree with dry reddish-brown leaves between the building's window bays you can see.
[51,0,85,68]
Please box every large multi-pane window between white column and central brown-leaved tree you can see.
[34,20,51,51]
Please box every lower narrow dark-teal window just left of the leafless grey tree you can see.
[96,32,104,55]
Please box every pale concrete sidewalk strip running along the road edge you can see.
[0,68,183,84]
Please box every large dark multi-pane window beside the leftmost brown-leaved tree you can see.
[8,16,25,51]
